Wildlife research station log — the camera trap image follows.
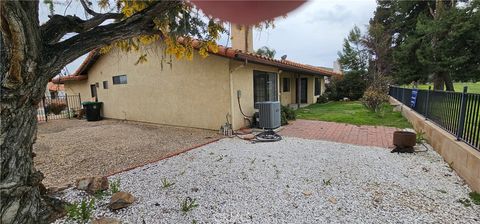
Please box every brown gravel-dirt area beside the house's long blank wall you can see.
[33,119,220,187]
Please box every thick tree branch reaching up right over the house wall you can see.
[42,1,183,78]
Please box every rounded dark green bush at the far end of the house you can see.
[325,71,367,101]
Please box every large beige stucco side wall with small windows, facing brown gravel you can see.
[65,45,231,129]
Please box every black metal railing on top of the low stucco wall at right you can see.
[389,86,480,151]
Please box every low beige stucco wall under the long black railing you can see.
[390,97,480,192]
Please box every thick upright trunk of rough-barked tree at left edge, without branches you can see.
[0,1,53,224]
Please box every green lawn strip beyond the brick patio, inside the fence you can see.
[297,101,412,128]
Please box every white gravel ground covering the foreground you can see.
[56,138,480,223]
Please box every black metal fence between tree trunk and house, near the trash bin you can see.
[37,94,82,122]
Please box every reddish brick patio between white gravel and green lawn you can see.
[280,120,398,148]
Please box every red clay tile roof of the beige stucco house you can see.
[52,38,341,83]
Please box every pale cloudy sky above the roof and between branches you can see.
[40,0,376,73]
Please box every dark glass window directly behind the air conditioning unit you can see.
[253,71,278,103]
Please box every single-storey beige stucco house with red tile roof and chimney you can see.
[54,25,340,130]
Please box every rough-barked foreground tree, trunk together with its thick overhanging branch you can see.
[0,0,182,224]
